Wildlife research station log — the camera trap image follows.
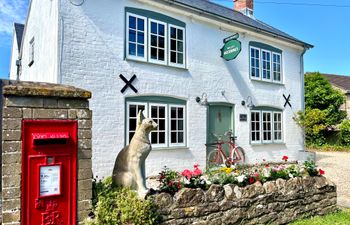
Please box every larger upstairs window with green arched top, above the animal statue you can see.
[126,8,186,68]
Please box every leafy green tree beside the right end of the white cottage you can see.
[297,72,346,145]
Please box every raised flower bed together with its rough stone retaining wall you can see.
[151,157,337,224]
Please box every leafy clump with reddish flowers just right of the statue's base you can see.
[158,166,182,195]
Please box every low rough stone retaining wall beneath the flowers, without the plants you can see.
[153,177,337,225]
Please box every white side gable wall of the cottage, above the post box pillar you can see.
[20,0,59,83]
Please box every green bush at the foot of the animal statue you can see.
[87,177,160,225]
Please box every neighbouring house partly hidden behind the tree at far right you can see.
[322,74,350,118]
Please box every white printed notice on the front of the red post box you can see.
[40,165,61,197]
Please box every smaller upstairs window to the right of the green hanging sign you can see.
[250,42,282,83]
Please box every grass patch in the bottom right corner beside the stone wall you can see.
[290,209,350,225]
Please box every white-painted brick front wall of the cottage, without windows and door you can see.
[55,0,304,177]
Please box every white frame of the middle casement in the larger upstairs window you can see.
[148,19,168,65]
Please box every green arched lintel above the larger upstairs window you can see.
[125,7,186,28]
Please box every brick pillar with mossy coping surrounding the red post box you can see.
[2,81,92,225]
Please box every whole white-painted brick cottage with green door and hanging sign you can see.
[10,0,312,177]
